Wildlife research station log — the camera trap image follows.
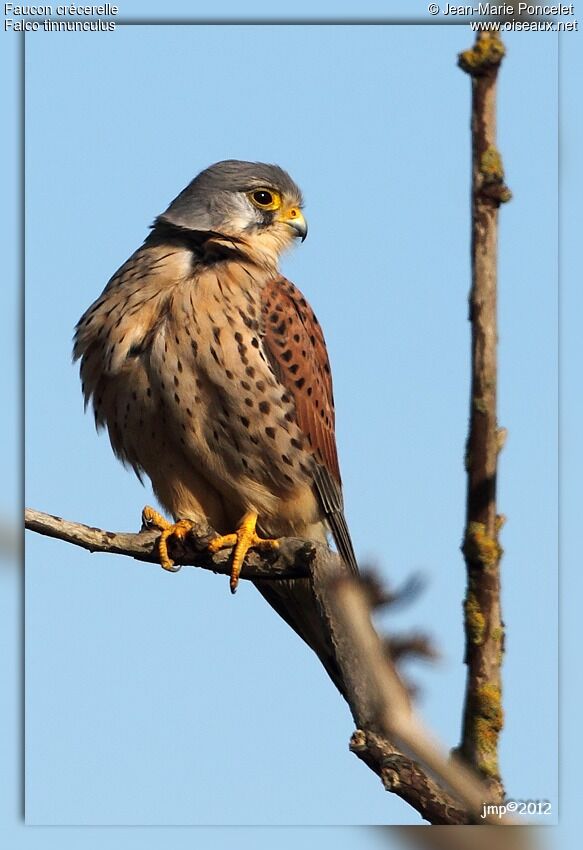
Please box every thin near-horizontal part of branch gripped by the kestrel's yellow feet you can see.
[24,508,314,581]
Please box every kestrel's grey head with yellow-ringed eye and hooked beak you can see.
[159,159,308,247]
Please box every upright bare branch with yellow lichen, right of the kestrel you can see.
[459,33,511,800]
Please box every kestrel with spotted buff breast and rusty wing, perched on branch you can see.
[73,160,358,692]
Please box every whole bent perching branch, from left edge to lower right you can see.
[25,508,502,824]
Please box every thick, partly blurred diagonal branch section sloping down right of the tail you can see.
[322,572,508,824]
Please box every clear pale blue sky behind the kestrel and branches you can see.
[2,1,570,846]
